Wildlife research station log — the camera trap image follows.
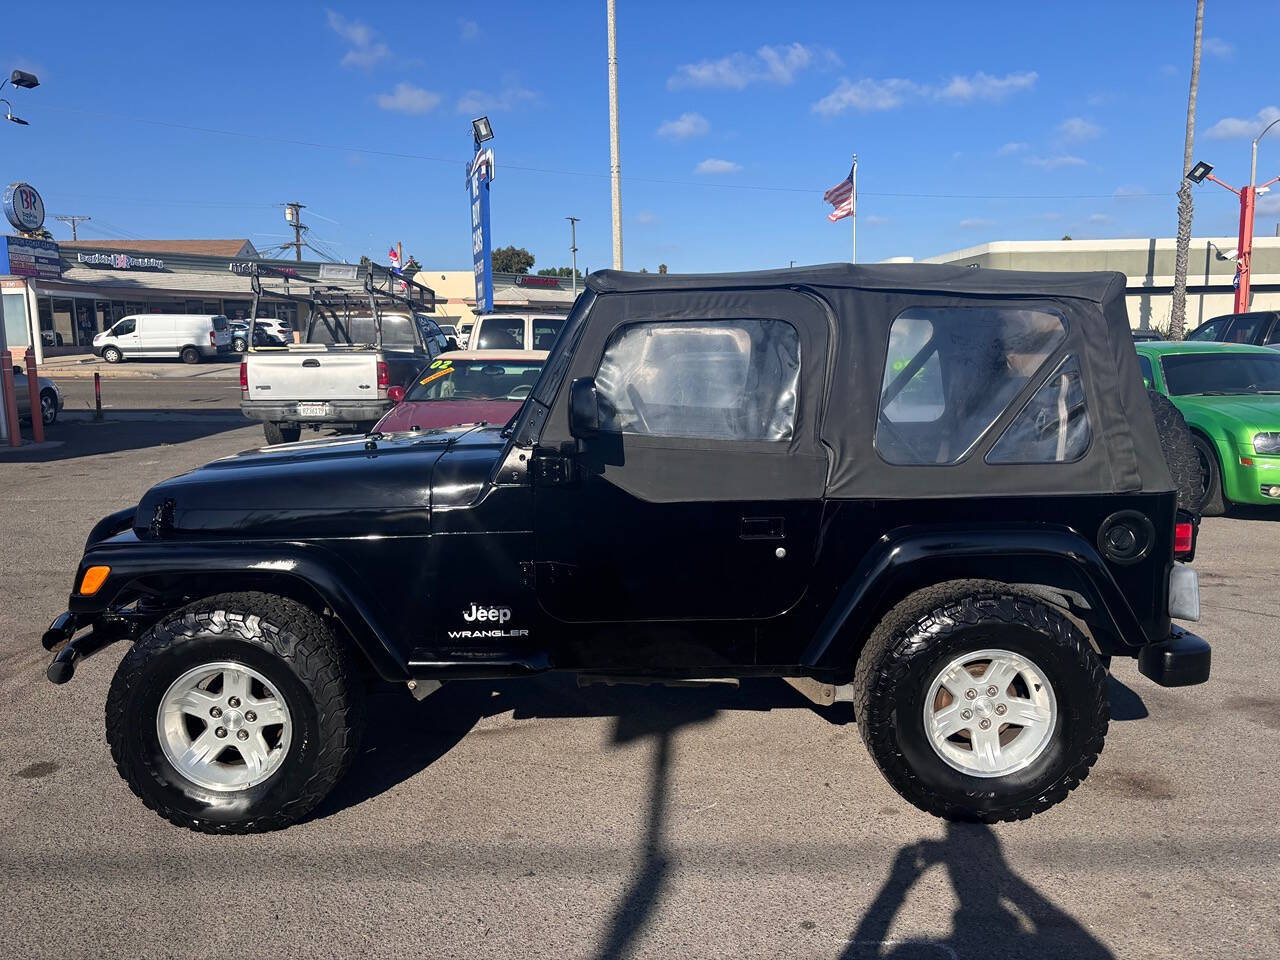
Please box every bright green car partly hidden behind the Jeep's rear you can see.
[1134,340,1280,515]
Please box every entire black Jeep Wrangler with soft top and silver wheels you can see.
[45,265,1210,832]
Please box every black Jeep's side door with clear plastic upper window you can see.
[534,291,829,662]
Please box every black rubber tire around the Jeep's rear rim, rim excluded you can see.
[854,585,1111,823]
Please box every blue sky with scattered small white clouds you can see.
[0,0,1280,271]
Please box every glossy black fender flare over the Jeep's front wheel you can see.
[69,535,410,681]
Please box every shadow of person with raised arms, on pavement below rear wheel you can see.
[842,823,1115,960]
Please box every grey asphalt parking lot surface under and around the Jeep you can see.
[0,409,1280,960]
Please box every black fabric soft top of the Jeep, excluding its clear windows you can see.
[560,264,1172,499]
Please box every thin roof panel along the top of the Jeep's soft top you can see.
[586,264,1128,302]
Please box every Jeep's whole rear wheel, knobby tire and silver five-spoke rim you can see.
[854,594,1110,823]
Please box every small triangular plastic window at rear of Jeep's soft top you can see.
[987,357,1093,463]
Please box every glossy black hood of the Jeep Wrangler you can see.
[133,429,481,539]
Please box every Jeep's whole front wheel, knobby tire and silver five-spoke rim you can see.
[106,593,361,833]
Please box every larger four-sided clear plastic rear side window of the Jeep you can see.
[876,306,1066,465]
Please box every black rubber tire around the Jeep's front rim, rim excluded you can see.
[106,593,364,833]
